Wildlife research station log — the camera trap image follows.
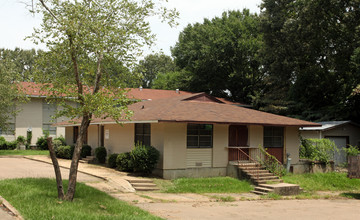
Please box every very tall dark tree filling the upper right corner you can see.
[258,0,360,120]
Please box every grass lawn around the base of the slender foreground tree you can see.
[0,178,160,220]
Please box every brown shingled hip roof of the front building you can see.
[58,93,319,127]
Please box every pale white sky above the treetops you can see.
[0,0,261,55]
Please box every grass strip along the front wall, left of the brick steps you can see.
[155,177,253,193]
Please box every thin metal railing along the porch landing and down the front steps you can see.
[228,146,286,176]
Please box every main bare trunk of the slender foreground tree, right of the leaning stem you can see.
[65,114,91,201]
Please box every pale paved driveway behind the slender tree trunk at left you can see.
[0,157,103,182]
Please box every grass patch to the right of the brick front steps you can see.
[283,172,360,192]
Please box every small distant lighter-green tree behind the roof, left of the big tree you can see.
[136,53,175,88]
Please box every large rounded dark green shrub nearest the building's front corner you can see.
[130,143,160,174]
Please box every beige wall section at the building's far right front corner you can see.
[284,127,300,164]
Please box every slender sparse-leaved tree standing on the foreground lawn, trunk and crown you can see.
[32,0,176,201]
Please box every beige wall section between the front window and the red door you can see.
[212,124,229,167]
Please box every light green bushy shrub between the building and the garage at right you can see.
[300,138,339,163]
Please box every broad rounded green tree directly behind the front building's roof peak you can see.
[172,9,263,103]
